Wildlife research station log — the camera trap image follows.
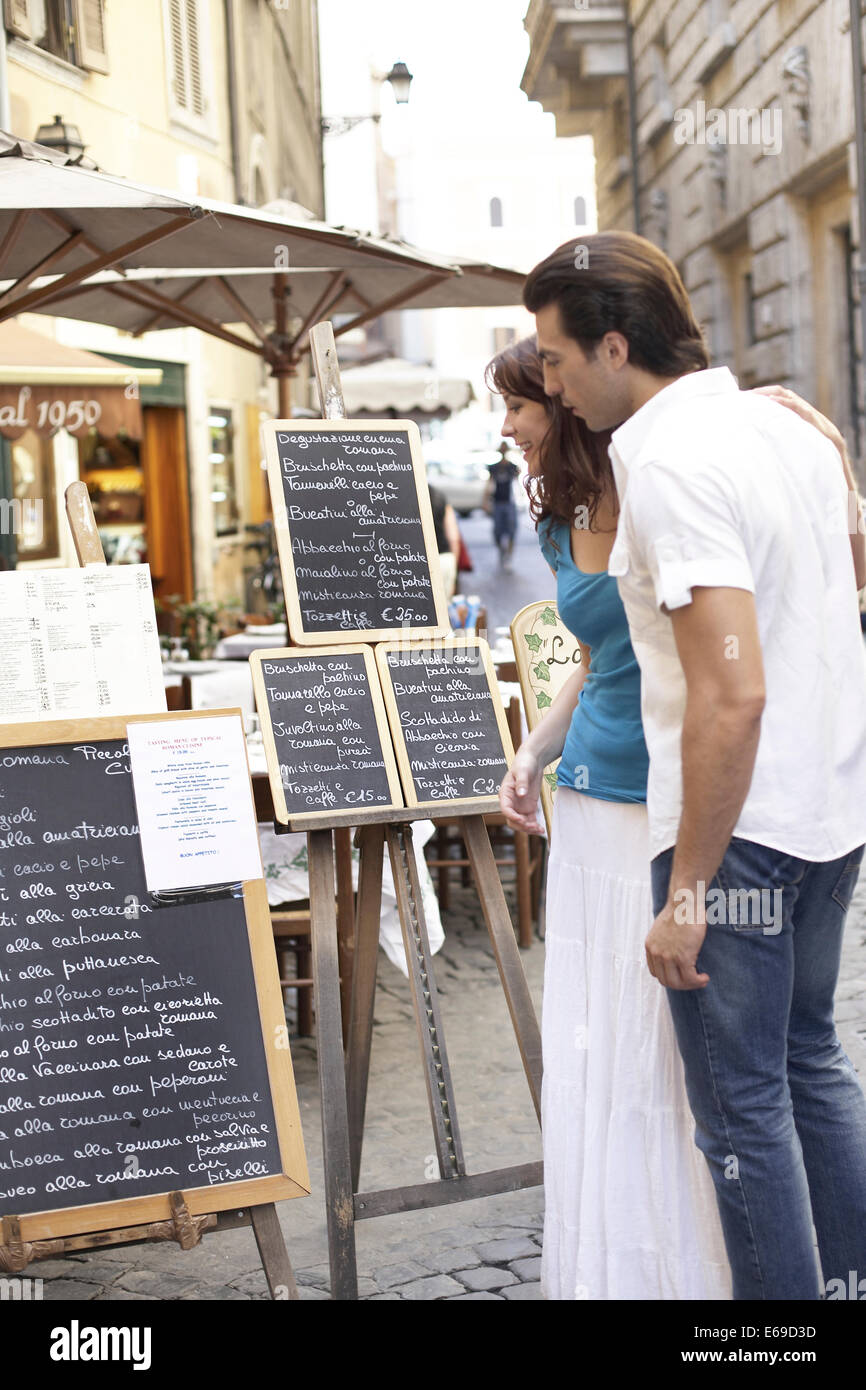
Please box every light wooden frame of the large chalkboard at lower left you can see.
[0,710,310,1241]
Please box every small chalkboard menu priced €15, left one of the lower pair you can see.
[250,646,403,824]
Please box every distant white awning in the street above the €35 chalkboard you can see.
[310,357,474,418]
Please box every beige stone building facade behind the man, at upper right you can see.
[523,0,866,461]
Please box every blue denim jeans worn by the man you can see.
[652,840,866,1300]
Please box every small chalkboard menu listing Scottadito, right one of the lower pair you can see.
[377,638,513,812]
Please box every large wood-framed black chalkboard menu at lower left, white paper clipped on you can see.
[0,716,309,1238]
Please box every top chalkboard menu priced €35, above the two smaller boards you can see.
[263,420,450,646]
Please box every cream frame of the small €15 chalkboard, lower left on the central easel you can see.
[250,645,403,826]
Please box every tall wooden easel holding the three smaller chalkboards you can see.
[278,322,542,1300]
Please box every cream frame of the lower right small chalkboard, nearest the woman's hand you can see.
[375,637,514,815]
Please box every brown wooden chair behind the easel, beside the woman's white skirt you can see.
[427,696,545,951]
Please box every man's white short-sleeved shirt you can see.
[609,367,866,862]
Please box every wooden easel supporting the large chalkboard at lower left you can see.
[0,482,304,1300]
